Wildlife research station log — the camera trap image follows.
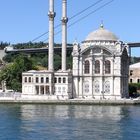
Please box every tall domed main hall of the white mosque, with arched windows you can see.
[73,27,129,99]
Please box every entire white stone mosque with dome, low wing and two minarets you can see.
[22,0,129,100]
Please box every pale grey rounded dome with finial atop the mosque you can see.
[85,25,118,41]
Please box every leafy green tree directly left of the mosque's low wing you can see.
[0,54,37,91]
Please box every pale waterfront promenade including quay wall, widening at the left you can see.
[0,93,140,105]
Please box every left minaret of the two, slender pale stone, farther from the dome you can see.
[48,0,55,71]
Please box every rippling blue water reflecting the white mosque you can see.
[0,104,140,140]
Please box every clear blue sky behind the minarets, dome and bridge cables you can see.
[0,0,140,56]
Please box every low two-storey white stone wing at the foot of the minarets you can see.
[22,70,72,99]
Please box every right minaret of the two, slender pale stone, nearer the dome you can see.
[61,0,68,71]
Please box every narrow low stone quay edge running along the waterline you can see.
[0,99,140,105]
